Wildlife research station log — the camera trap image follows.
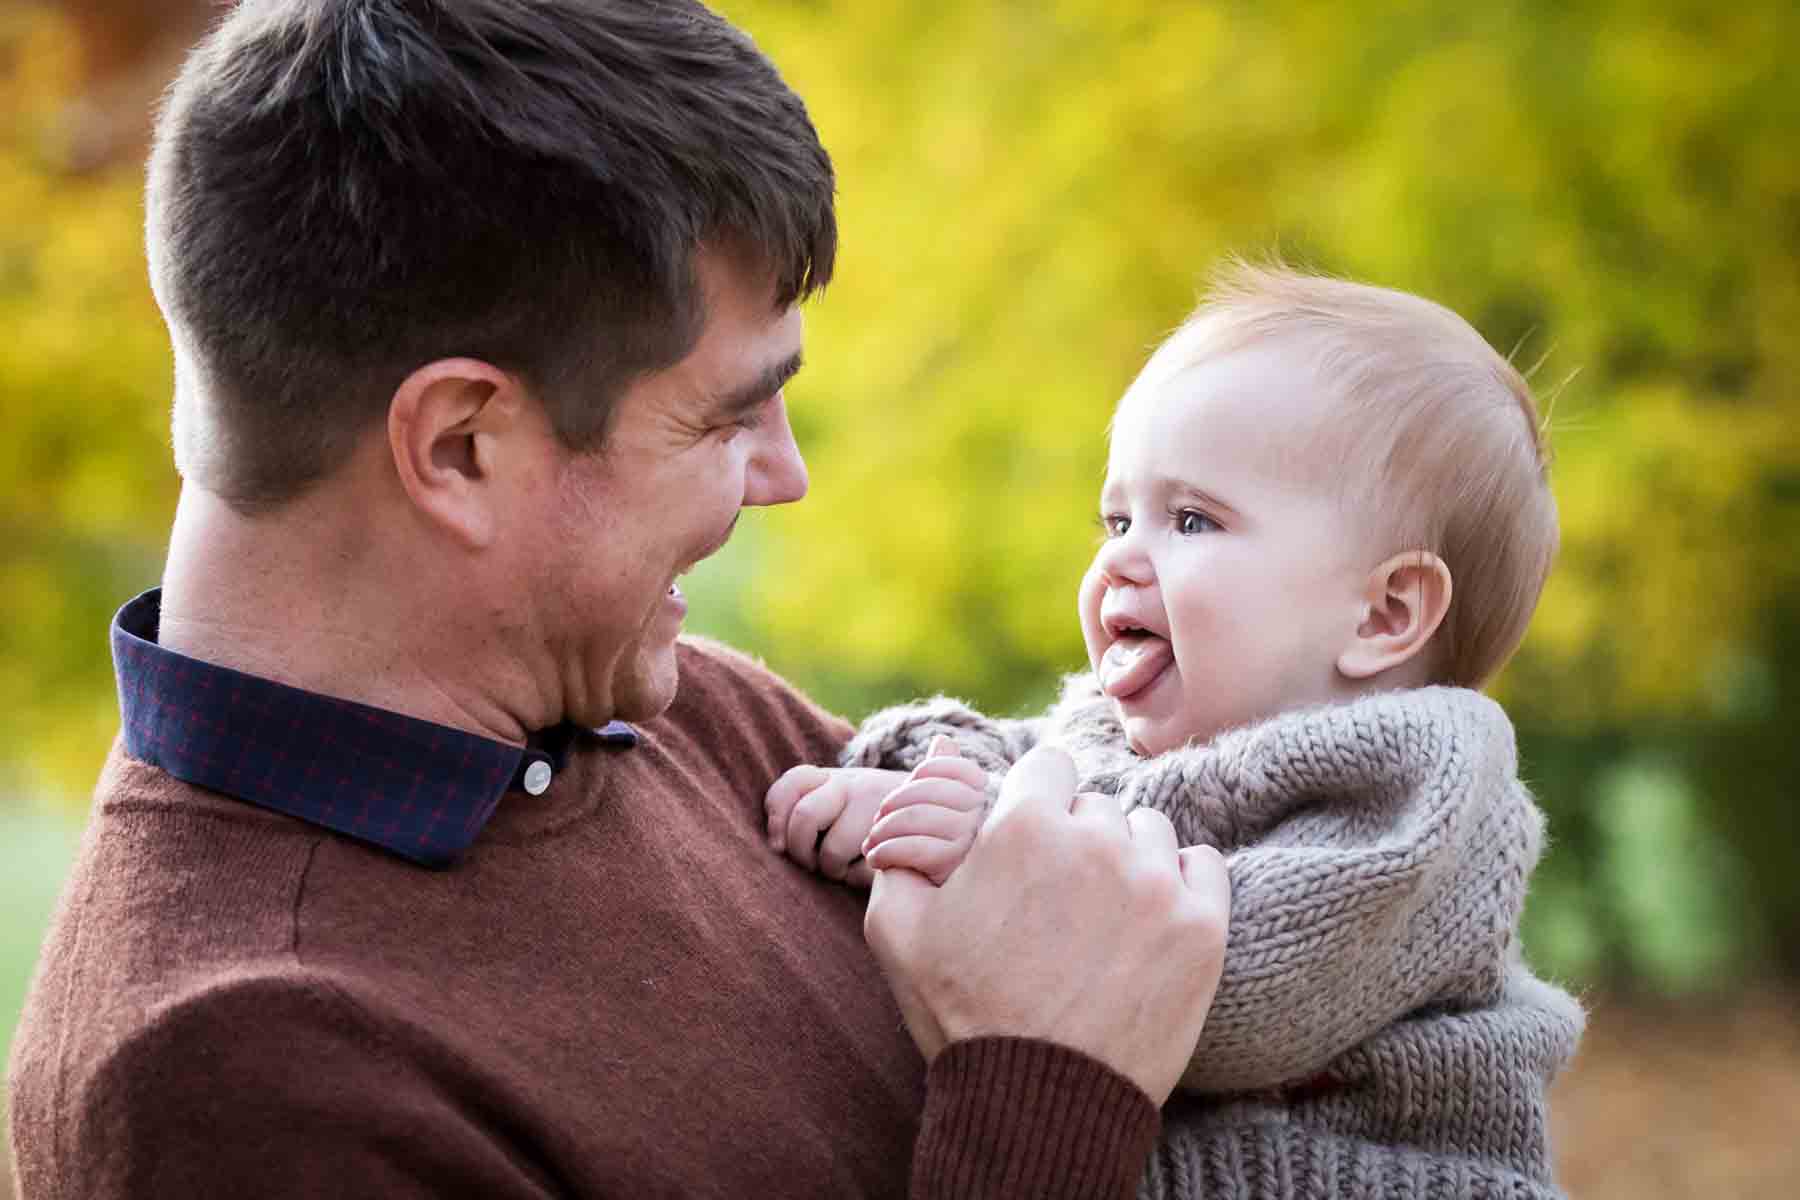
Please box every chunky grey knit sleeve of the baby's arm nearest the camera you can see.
[1121,689,1543,1092]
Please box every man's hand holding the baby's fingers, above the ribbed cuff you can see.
[864,747,1231,1105]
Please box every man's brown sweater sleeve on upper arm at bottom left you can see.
[20,977,556,1200]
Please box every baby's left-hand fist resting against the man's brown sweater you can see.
[763,766,909,887]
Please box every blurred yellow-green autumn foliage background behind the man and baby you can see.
[0,0,1800,1198]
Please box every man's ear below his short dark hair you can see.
[387,358,535,551]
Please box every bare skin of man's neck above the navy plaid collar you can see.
[158,486,551,745]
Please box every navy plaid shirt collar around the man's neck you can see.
[112,588,637,867]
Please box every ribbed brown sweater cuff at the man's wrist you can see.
[911,1036,1159,1200]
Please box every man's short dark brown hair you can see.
[148,0,837,511]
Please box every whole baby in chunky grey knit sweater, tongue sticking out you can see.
[767,264,1582,1196]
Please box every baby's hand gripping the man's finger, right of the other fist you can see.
[862,738,988,885]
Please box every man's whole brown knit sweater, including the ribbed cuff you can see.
[11,644,1157,1200]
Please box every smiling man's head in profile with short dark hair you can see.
[148,0,837,736]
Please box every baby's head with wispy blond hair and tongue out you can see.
[1080,264,1557,752]
